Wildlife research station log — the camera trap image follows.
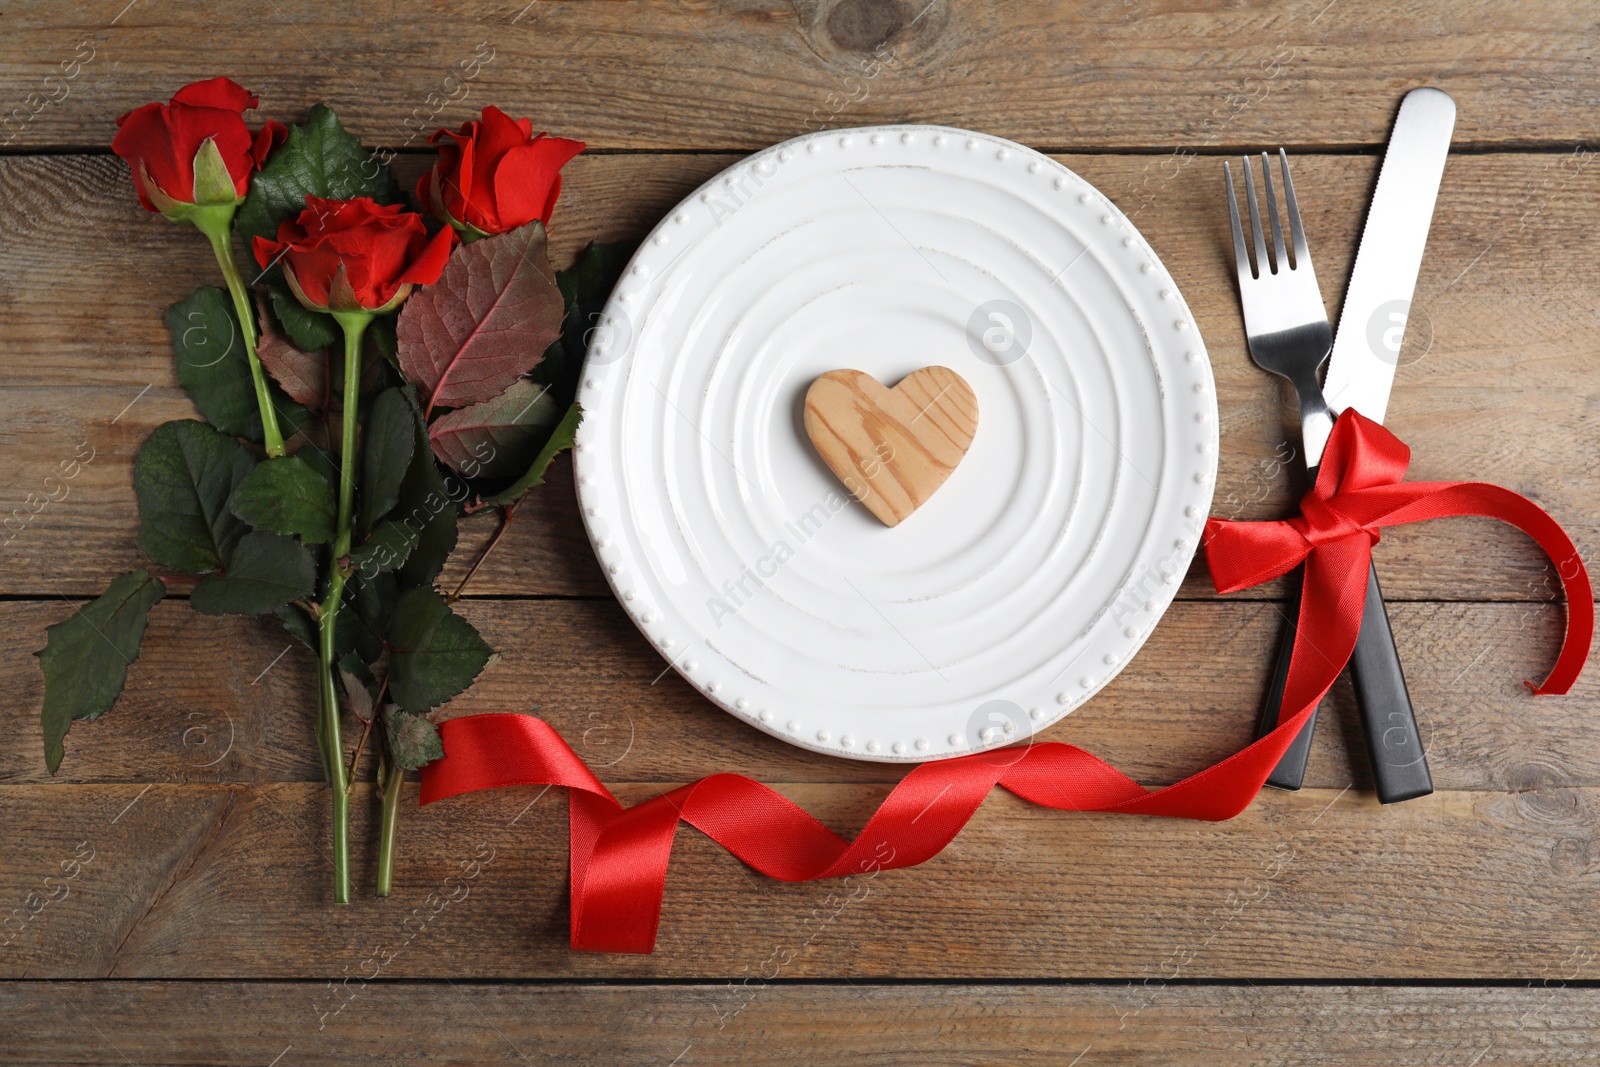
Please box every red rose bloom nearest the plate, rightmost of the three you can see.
[416,107,587,237]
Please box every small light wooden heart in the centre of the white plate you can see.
[805,366,978,526]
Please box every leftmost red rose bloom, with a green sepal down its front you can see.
[110,78,288,214]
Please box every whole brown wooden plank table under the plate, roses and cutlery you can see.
[0,0,1600,1067]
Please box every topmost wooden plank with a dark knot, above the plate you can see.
[0,0,1600,149]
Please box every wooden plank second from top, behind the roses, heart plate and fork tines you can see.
[0,155,1600,600]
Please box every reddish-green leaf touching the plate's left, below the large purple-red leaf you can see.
[427,378,562,478]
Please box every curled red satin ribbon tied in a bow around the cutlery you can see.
[422,410,1594,952]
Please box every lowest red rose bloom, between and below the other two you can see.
[254,197,456,312]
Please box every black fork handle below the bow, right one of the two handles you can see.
[1350,566,1434,805]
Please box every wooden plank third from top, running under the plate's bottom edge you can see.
[0,600,1580,790]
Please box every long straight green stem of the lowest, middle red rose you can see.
[308,310,373,904]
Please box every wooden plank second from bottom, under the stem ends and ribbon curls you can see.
[0,784,1600,979]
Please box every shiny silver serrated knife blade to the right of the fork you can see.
[1322,88,1456,422]
